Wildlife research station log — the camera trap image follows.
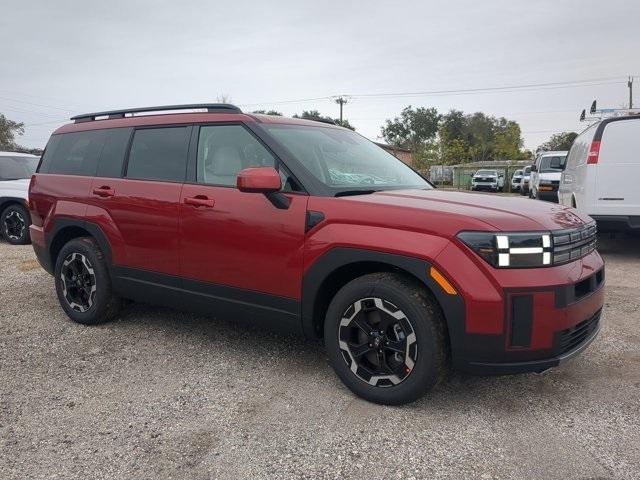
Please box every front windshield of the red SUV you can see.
[265,125,432,194]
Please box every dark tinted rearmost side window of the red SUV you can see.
[40,130,107,176]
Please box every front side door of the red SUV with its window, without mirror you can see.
[180,124,308,327]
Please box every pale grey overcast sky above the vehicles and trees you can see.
[0,0,640,148]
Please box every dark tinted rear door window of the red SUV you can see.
[127,127,190,182]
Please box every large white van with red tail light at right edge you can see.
[558,115,640,231]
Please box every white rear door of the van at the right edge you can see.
[588,118,640,215]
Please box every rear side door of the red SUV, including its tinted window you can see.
[87,126,192,287]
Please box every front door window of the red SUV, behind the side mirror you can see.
[197,125,275,186]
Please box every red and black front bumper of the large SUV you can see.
[436,245,605,375]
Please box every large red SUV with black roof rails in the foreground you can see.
[29,104,604,404]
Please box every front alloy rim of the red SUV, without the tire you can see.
[338,297,418,387]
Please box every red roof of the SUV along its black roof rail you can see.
[53,112,344,135]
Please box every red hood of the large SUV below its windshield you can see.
[345,189,592,235]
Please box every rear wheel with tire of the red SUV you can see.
[54,237,122,325]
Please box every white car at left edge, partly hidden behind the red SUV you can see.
[0,152,40,245]
